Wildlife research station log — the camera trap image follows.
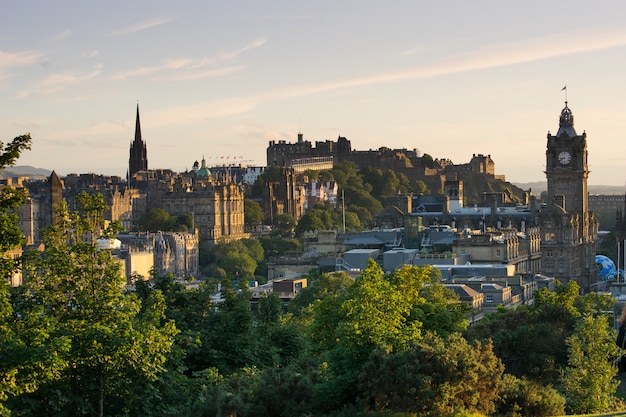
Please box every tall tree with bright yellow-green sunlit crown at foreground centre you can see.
[310,260,444,409]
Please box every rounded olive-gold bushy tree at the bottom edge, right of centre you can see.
[359,333,504,416]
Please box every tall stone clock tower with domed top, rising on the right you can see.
[537,102,598,291]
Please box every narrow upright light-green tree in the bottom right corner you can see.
[563,316,619,414]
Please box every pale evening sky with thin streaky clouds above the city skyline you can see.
[0,0,626,186]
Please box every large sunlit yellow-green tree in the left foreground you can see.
[14,193,177,416]
